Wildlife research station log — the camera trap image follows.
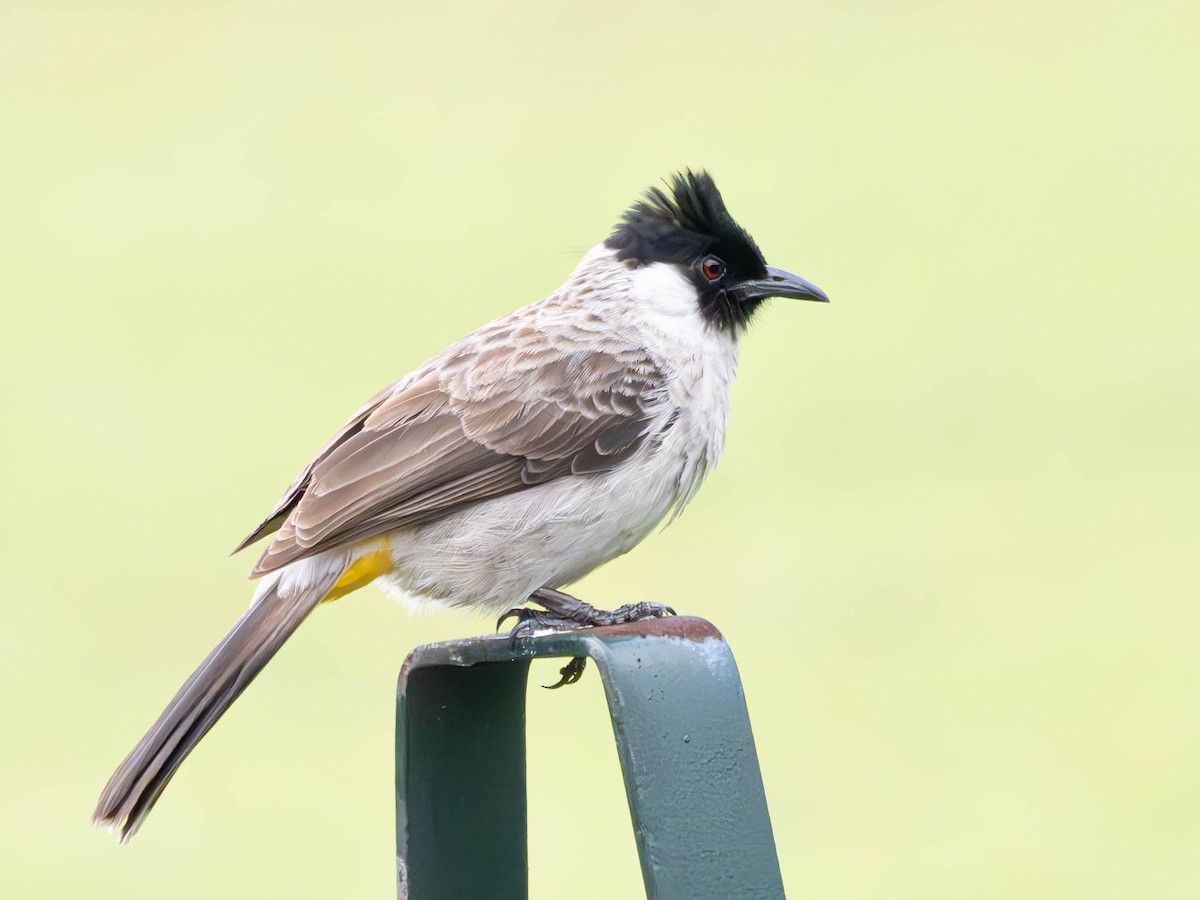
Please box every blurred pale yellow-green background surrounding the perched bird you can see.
[0,0,1200,900]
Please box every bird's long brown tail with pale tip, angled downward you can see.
[92,571,338,842]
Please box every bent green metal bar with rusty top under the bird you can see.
[396,617,784,900]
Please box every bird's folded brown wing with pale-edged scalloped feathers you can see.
[234,335,667,576]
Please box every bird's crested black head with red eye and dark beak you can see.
[605,170,829,329]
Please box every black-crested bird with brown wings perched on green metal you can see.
[92,169,829,842]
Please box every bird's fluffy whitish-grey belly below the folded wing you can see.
[380,445,697,611]
